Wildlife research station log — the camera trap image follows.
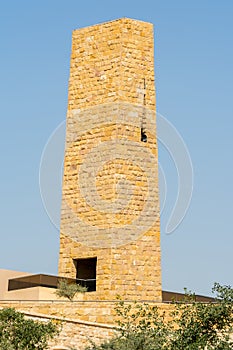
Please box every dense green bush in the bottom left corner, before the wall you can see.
[0,308,59,350]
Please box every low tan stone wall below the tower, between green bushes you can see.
[0,301,171,350]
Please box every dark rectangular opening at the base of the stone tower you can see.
[74,258,97,292]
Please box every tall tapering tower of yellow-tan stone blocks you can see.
[59,18,162,301]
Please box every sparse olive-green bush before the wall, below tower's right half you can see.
[87,301,169,350]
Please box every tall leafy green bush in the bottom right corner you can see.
[170,283,233,350]
